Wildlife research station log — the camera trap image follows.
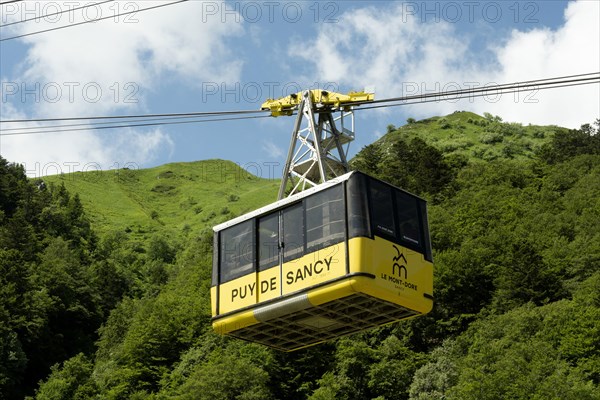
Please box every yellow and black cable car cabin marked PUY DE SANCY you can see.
[211,172,433,351]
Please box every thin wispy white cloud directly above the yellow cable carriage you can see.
[289,4,466,101]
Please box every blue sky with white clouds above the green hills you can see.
[0,0,600,177]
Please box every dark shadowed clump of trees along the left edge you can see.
[0,157,101,399]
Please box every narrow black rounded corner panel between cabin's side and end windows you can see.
[346,173,371,238]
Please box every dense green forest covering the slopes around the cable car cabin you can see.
[0,114,600,400]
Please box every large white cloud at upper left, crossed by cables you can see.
[0,1,243,175]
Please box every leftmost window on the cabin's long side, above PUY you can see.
[220,220,255,283]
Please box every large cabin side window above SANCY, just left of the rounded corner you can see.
[305,185,346,252]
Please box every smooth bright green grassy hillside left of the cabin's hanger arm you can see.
[44,160,279,237]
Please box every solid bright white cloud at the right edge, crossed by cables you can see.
[488,1,600,128]
